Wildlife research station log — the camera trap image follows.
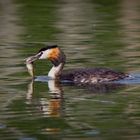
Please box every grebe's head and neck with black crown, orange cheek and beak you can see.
[26,45,66,79]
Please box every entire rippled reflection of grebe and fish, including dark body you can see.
[26,77,124,136]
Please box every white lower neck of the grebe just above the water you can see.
[48,63,64,79]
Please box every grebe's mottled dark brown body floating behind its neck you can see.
[60,68,128,83]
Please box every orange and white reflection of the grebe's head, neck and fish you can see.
[26,80,64,134]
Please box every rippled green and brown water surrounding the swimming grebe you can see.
[0,0,140,140]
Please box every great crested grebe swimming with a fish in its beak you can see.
[26,45,129,84]
